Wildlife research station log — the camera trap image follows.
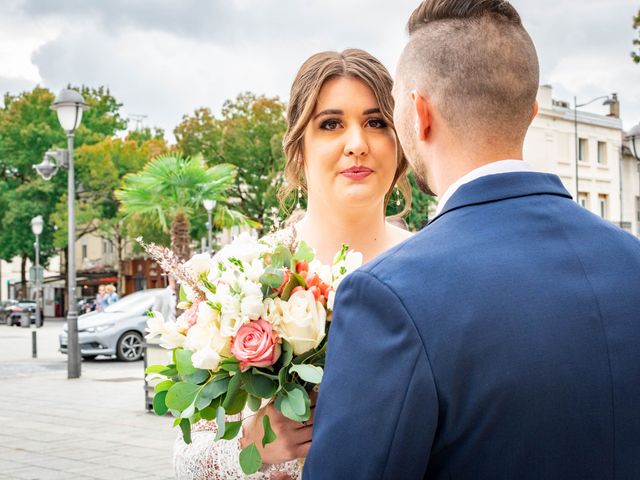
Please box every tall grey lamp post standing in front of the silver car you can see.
[34,89,89,378]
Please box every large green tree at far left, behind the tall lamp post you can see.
[0,87,126,285]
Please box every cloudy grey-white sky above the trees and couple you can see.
[0,0,640,141]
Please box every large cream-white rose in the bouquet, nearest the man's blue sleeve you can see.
[276,290,327,355]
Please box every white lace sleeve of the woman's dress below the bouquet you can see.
[173,415,301,480]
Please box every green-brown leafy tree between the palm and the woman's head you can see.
[174,92,287,234]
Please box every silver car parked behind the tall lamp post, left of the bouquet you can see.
[58,288,163,362]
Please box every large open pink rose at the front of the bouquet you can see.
[231,318,281,372]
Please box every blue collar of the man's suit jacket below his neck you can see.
[429,172,572,225]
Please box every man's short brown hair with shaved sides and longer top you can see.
[398,0,539,142]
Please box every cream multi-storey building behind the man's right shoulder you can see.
[523,85,640,235]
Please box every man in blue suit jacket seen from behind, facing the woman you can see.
[304,0,640,480]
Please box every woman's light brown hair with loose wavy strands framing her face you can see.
[279,48,411,216]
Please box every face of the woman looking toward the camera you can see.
[304,77,397,212]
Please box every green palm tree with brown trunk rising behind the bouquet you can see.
[115,154,259,260]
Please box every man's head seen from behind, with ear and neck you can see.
[394,0,538,195]
